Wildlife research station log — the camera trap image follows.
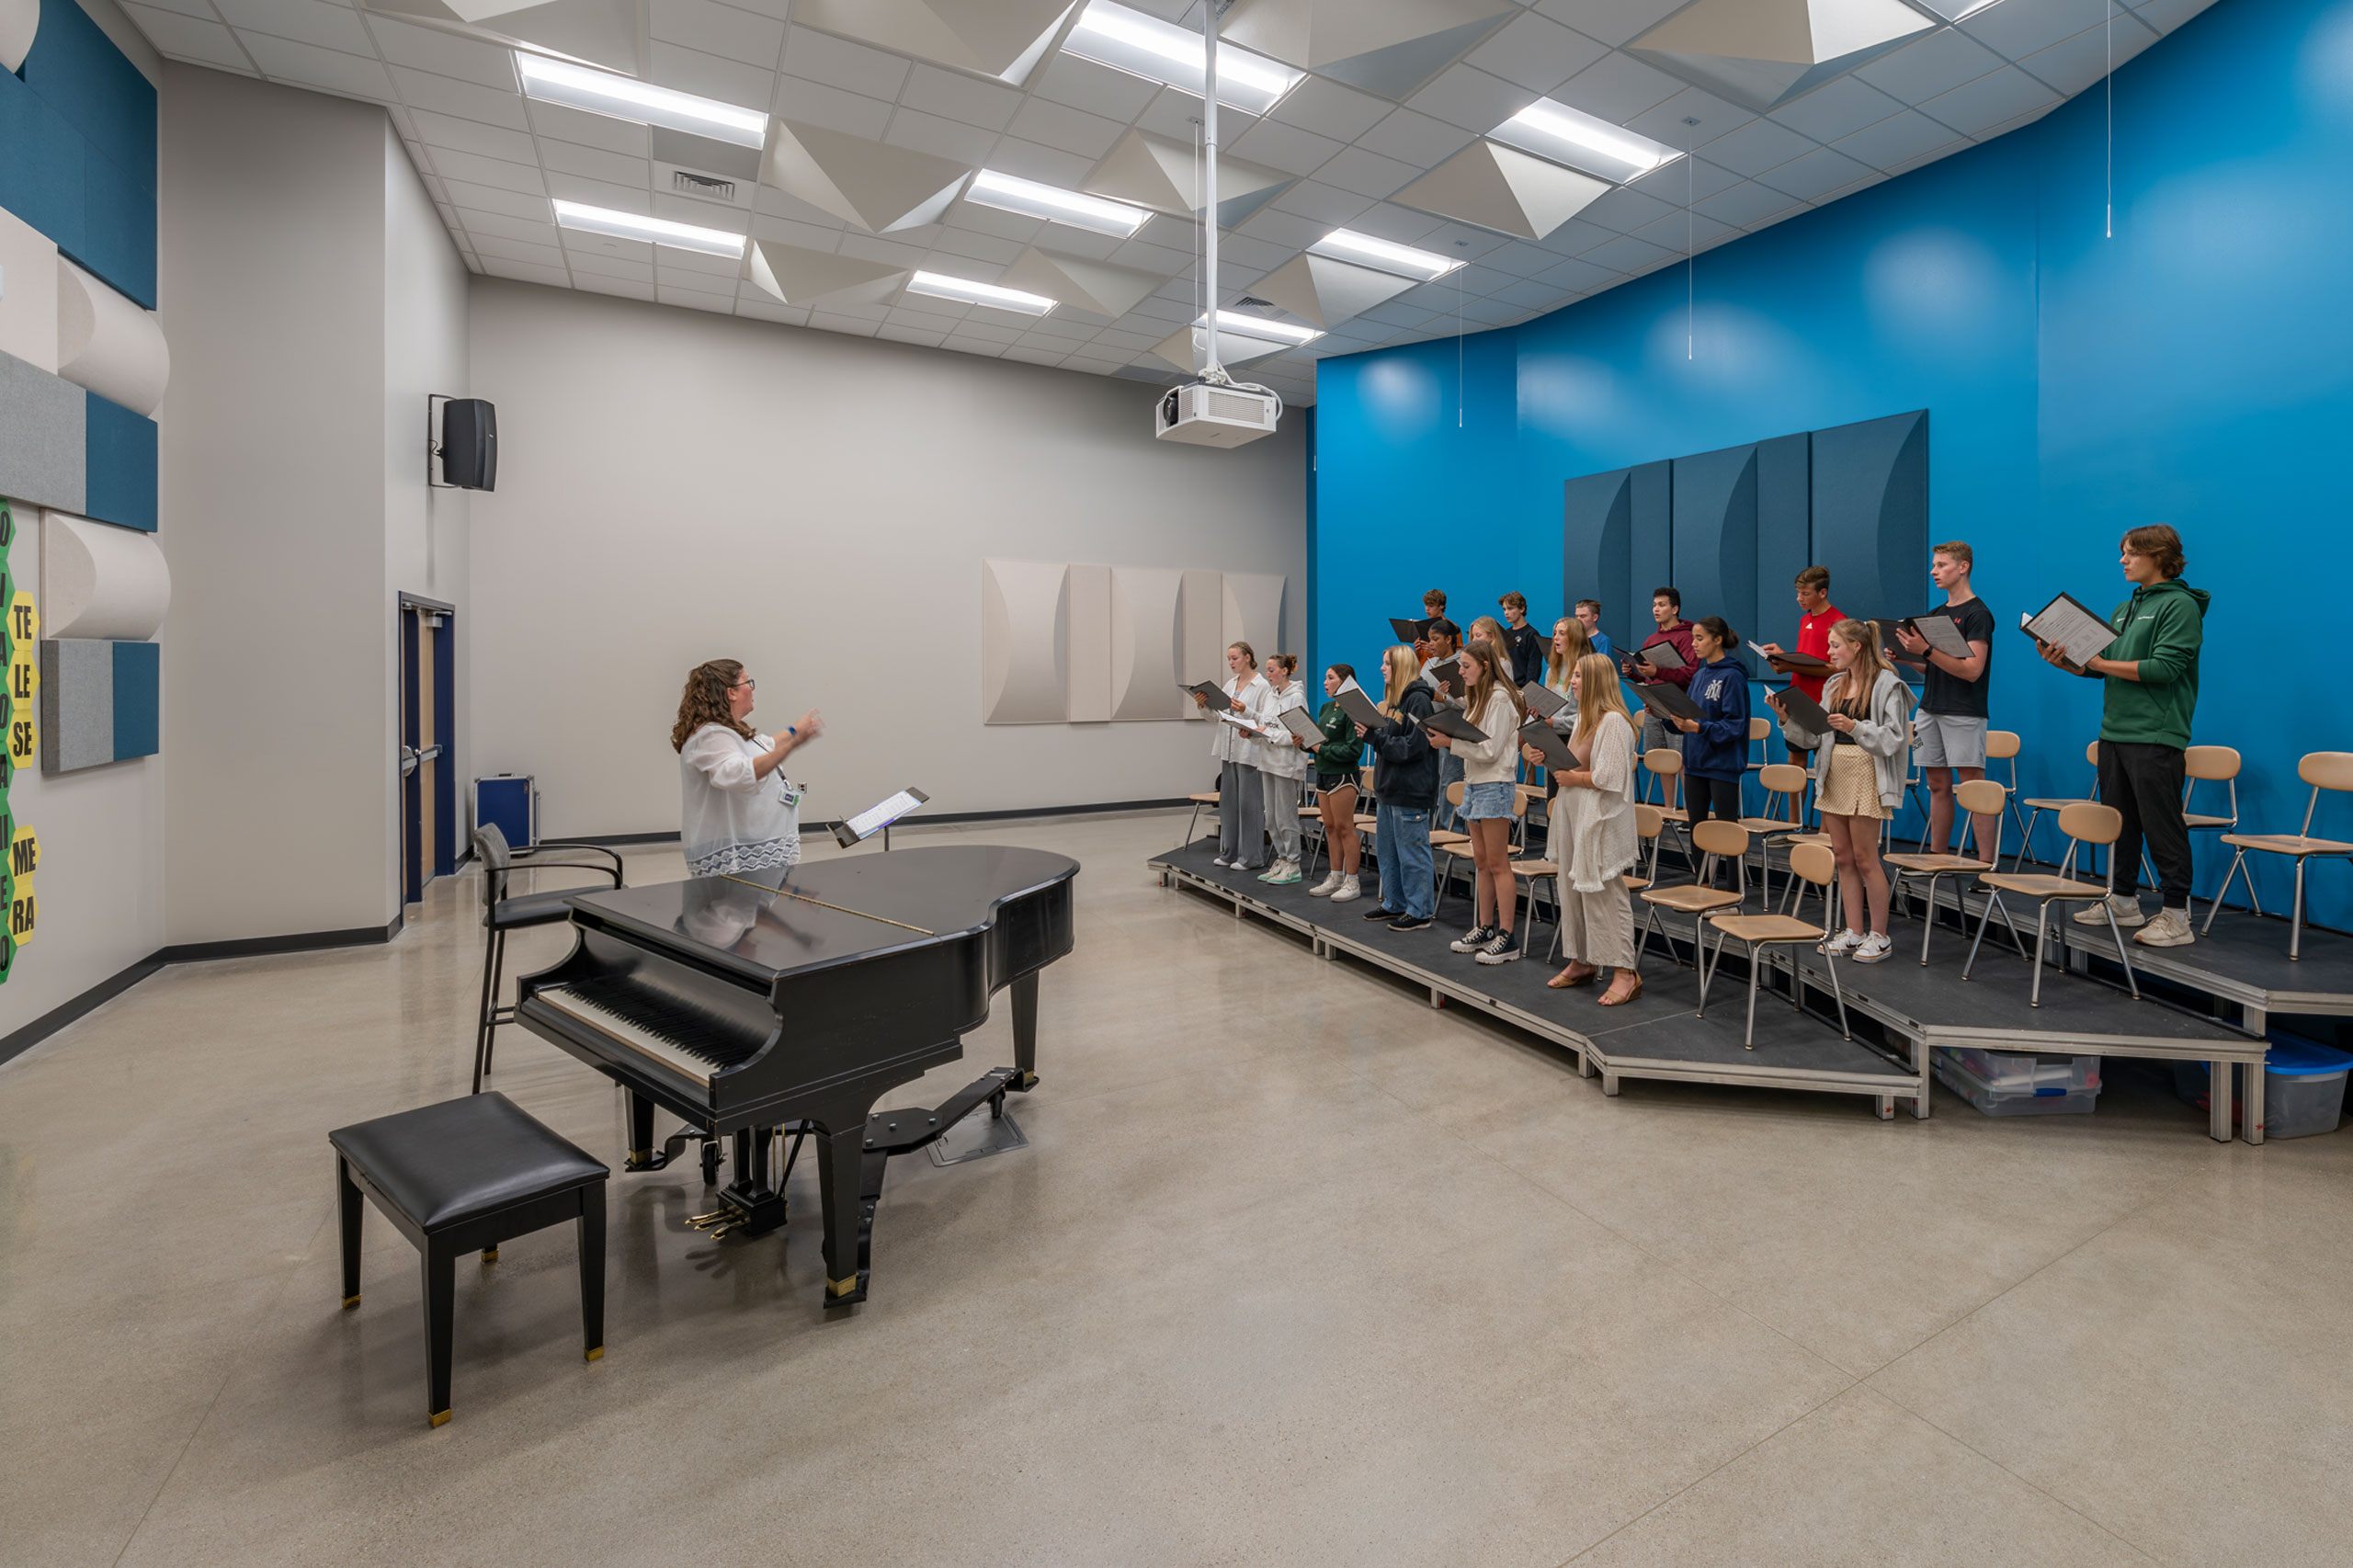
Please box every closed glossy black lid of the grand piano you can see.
[570,846,1077,984]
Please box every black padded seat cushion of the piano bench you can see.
[327,1093,609,1232]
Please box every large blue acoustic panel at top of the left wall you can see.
[0,0,155,311]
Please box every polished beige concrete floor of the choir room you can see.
[0,814,2353,1568]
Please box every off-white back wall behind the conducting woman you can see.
[471,278,1306,835]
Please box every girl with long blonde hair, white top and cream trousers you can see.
[1527,653,1643,1007]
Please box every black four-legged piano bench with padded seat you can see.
[327,1093,609,1426]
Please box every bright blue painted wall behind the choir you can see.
[1311,0,2353,926]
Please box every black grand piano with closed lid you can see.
[516,846,1077,1307]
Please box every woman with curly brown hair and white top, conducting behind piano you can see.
[671,659,826,876]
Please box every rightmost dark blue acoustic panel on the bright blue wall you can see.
[1814,410,1927,615]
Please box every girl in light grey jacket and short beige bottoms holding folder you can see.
[1765,619,1913,963]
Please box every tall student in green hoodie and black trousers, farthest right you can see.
[2035,523,2207,947]
